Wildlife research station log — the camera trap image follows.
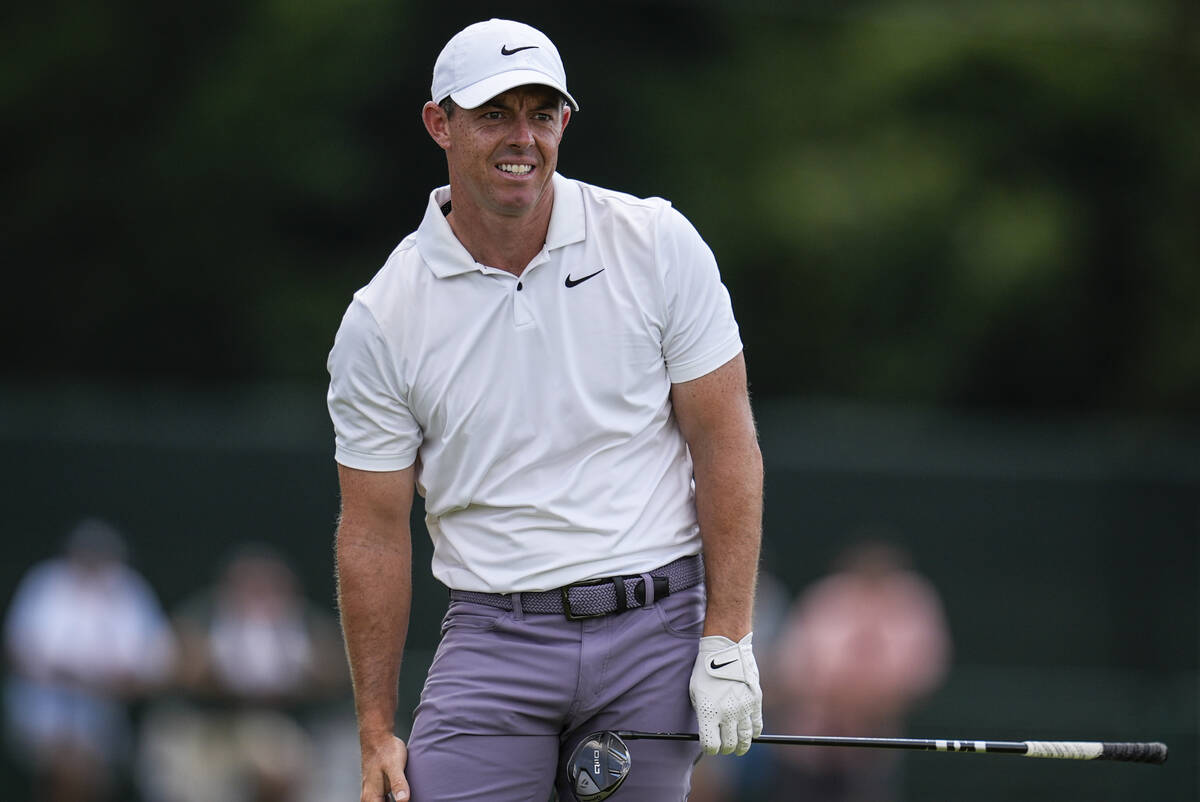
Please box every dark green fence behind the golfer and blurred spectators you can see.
[0,388,1200,801]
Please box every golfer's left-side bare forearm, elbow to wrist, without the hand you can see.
[337,515,413,736]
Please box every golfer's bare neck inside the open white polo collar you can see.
[446,181,554,276]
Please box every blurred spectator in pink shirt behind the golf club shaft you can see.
[769,540,950,802]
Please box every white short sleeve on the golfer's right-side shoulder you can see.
[656,207,742,383]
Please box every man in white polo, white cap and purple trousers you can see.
[329,19,762,802]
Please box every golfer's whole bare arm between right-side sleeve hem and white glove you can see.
[671,354,762,641]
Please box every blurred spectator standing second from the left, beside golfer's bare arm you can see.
[139,545,353,802]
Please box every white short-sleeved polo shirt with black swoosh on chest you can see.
[328,175,742,593]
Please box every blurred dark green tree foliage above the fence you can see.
[0,0,1200,414]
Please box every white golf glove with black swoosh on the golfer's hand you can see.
[690,633,762,755]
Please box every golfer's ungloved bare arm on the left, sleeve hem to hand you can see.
[337,466,414,802]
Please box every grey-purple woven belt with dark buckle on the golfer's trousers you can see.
[450,555,704,621]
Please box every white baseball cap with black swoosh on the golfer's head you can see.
[432,19,580,112]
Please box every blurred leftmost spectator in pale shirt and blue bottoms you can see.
[5,519,173,802]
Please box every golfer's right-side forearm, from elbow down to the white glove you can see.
[692,432,762,641]
